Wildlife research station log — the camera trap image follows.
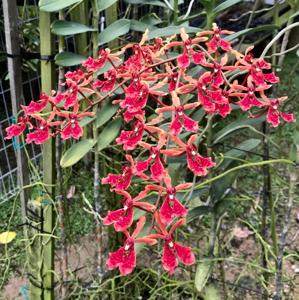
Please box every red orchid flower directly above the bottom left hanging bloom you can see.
[103,190,156,231]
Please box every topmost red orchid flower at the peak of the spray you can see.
[197,23,233,53]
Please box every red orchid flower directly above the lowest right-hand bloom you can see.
[145,172,192,225]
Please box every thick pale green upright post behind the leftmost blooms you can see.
[39,11,55,300]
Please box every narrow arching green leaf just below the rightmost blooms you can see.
[213,116,265,144]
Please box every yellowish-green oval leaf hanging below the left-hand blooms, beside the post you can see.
[60,139,96,168]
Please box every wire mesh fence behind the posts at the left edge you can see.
[0,1,41,204]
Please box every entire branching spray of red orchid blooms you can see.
[6,24,294,275]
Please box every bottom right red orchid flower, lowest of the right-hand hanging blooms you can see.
[148,212,195,274]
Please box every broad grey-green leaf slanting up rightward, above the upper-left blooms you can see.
[99,19,131,45]
